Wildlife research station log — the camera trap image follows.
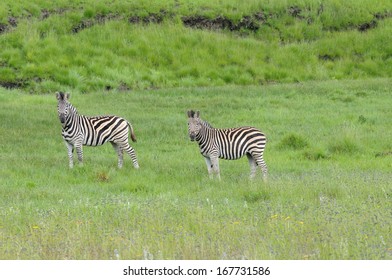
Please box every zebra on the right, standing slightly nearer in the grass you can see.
[188,111,267,180]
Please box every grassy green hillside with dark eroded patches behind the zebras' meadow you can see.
[0,0,392,93]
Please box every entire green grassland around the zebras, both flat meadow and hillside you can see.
[0,0,392,260]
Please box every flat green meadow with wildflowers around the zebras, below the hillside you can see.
[0,79,392,259]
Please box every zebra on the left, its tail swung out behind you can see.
[56,92,139,168]
